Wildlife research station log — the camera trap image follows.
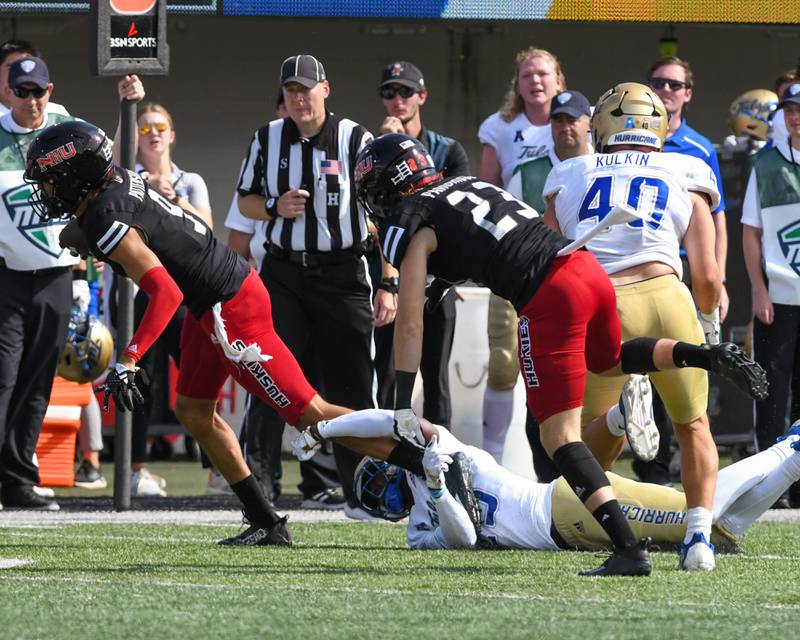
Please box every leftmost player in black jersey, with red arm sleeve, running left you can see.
[25,120,366,546]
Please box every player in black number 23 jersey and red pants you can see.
[355,134,766,576]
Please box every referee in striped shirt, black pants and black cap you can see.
[237,55,397,516]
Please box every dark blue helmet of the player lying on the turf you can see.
[353,457,411,521]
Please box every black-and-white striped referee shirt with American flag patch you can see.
[237,112,372,252]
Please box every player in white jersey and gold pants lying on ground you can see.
[292,409,800,551]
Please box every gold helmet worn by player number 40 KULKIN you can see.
[592,82,669,152]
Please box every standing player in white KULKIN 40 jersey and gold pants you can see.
[544,82,722,571]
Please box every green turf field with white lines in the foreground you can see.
[0,514,800,640]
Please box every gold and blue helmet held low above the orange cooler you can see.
[58,317,114,383]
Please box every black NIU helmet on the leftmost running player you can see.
[23,120,114,219]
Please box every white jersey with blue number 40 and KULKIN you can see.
[544,151,719,277]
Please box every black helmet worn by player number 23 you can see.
[355,133,441,219]
